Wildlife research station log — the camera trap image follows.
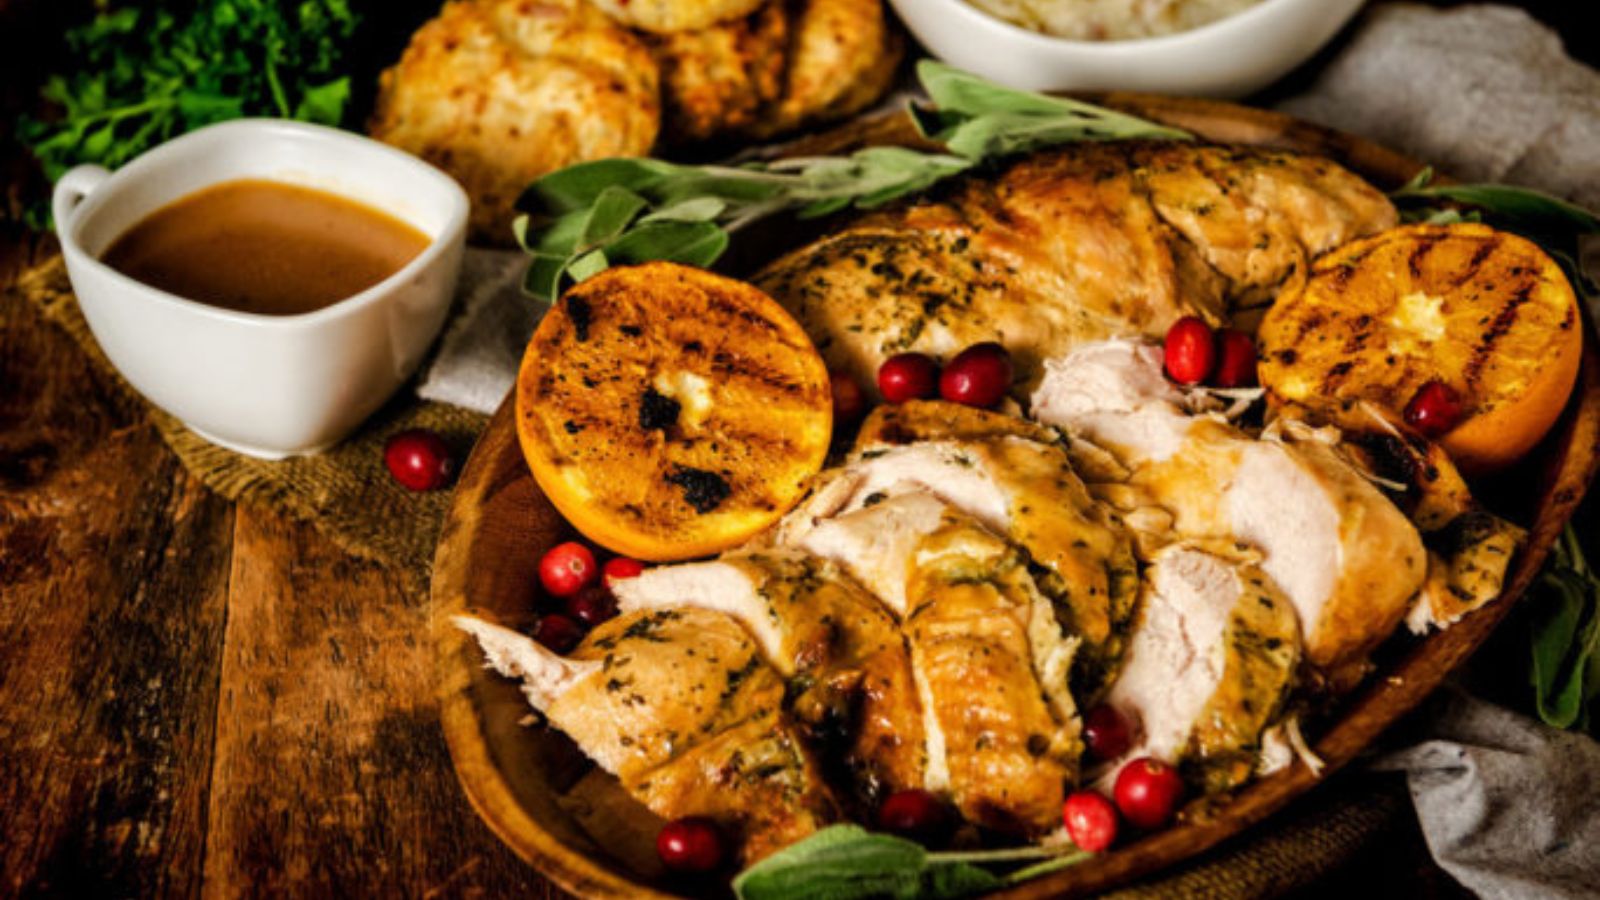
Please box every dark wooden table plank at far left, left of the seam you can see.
[0,295,232,897]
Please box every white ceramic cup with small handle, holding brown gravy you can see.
[54,119,467,458]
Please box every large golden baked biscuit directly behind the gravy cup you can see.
[370,0,661,243]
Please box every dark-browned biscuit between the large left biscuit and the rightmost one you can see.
[648,0,789,143]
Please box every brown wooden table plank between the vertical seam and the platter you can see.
[205,504,549,897]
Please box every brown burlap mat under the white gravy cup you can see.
[14,255,488,576]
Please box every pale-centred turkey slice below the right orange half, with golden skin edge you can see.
[1032,341,1427,673]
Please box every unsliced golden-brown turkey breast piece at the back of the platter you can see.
[755,143,1395,393]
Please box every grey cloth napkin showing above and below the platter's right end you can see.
[1280,3,1600,898]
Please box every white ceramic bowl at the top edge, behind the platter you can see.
[891,0,1362,98]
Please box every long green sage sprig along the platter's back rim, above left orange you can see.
[515,61,1189,299]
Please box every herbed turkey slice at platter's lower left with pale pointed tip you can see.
[454,609,837,863]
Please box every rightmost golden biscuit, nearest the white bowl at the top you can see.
[750,0,904,138]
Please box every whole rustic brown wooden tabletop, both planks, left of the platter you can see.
[0,0,1587,897]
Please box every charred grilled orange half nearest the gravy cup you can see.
[517,263,834,560]
